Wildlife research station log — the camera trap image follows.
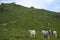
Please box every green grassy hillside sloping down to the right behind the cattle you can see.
[0,3,60,40]
